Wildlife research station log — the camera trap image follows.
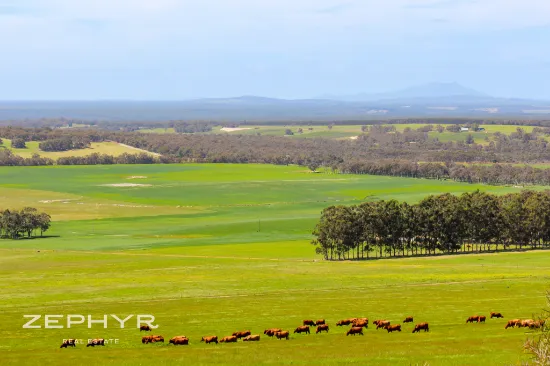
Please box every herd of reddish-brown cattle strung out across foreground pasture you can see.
[60,312,545,348]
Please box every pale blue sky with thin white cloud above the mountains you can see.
[0,0,550,100]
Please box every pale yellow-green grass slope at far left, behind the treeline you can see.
[0,138,157,159]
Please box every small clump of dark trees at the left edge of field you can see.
[0,207,51,239]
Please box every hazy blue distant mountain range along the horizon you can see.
[0,83,550,121]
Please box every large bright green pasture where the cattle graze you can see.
[0,164,550,365]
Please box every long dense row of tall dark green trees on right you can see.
[312,191,550,260]
